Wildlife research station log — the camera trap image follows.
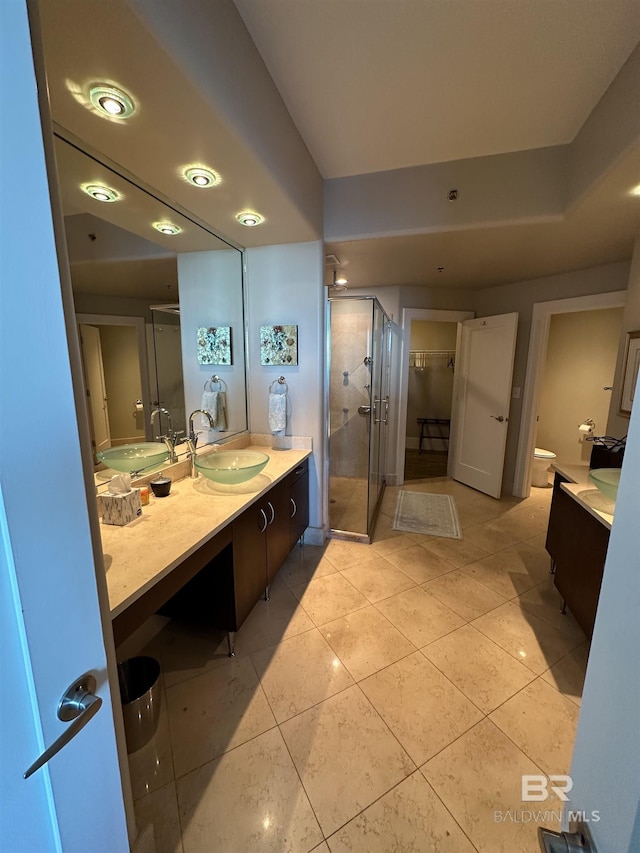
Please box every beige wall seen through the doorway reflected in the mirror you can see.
[98,326,144,444]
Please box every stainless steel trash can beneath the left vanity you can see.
[118,657,161,752]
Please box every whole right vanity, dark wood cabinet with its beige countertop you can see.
[545,464,613,637]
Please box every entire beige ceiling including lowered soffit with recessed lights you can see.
[40,0,640,288]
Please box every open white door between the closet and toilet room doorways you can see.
[448,314,518,498]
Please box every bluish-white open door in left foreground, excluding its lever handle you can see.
[0,0,129,853]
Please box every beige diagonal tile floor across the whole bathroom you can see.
[130,478,588,853]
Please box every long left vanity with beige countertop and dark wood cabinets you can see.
[100,445,311,654]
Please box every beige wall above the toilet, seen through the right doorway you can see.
[536,308,623,465]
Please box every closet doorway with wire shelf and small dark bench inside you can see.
[396,308,474,485]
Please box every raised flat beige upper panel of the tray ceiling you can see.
[234,0,640,178]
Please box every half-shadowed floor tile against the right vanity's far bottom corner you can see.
[463,543,549,598]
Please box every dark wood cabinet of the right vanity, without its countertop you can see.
[545,474,609,637]
